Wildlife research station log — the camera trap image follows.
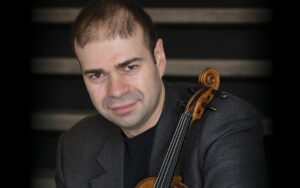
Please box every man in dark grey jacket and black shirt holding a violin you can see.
[56,0,266,188]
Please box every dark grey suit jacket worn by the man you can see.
[56,83,267,188]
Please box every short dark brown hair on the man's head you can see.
[71,0,157,52]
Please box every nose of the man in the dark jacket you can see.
[108,75,128,97]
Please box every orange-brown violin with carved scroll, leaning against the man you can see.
[135,68,220,188]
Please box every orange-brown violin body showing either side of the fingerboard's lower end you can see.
[135,175,188,188]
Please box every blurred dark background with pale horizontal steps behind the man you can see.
[30,0,274,188]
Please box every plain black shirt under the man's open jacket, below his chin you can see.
[123,126,156,188]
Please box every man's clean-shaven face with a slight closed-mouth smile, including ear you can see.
[75,28,166,135]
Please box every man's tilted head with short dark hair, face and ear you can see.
[73,0,166,137]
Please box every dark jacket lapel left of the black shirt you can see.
[90,129,124,188]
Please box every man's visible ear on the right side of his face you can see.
[154,39,167,77]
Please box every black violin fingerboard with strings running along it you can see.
[155,108,192,187]
